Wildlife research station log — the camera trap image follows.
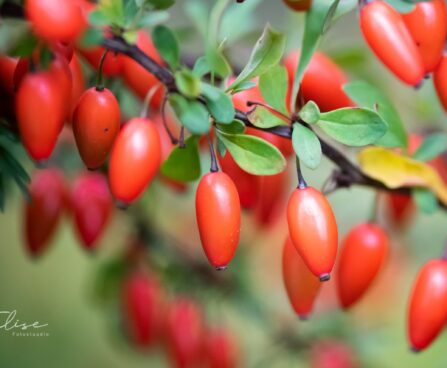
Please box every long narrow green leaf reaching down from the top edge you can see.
[291,0,339,111]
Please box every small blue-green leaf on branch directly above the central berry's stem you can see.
[201,83,236,124]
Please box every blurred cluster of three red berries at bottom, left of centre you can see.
[121,271,240,368]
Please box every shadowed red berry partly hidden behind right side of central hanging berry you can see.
[218,152,259,209]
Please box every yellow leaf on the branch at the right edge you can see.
[358,147,447,204]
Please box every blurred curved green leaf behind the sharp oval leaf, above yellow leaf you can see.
[343,81,407,147]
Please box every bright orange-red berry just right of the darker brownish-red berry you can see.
[109,118,161,204]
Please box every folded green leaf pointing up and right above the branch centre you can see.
[228,24,286,90]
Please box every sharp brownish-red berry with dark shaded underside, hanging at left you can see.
[73,87,121,169]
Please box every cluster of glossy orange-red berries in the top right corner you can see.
[360,0,447,111]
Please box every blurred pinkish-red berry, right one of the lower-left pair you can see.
[71,173,113,250]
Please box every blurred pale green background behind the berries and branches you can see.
[0,0,447,368]
